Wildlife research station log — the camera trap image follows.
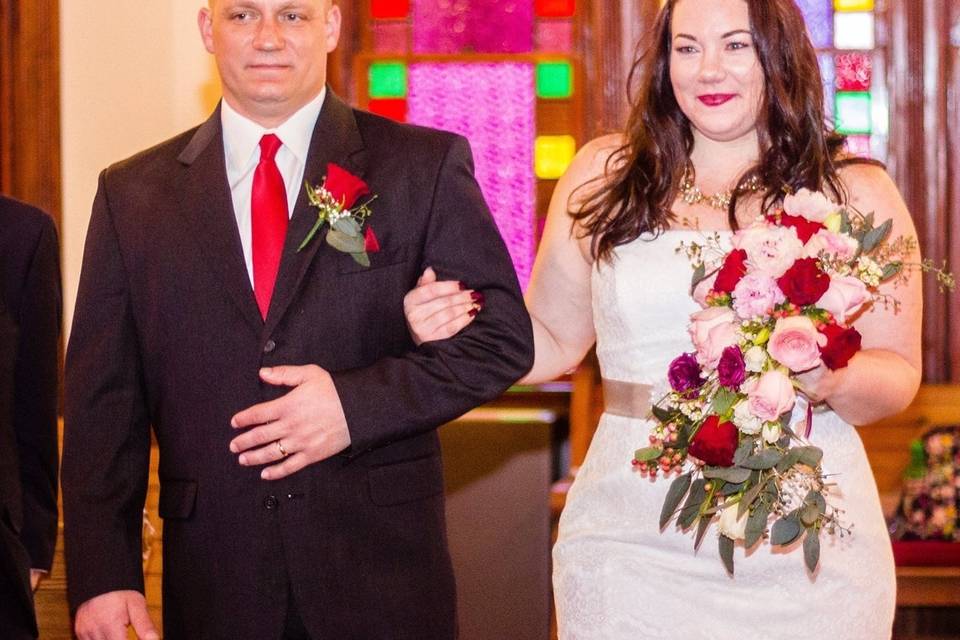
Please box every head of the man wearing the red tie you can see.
[198,0,340,127]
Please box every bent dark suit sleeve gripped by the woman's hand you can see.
[331,136,533,455]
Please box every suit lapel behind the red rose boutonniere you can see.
[264,93,366,335]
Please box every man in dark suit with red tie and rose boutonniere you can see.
[63,0,533,640]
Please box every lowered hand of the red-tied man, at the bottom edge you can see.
[74,591,160,640]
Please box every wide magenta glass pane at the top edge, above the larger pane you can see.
[413,0,534,53]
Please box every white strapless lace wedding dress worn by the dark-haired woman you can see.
[553,231,896,640]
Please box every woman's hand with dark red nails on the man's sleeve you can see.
[403,267,484,345]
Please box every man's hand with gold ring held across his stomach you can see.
[230,365,350,480]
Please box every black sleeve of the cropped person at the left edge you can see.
[13,215,61,570]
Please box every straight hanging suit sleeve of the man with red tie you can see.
[61,174,150,609]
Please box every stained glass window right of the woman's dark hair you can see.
[796,0,889,160]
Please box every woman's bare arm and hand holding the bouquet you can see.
[800,164,923,424]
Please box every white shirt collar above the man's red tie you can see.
[220,87,327,173]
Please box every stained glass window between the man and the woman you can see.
[358,0,584,287]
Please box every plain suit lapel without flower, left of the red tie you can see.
[177,107,263,336]
